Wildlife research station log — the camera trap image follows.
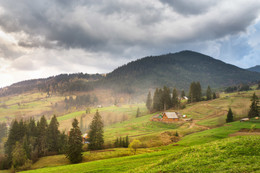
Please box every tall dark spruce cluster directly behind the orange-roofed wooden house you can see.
[146,86,180,111]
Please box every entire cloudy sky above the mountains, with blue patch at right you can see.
[0,0,260,87]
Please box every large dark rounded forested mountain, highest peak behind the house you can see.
[101,51,260,93]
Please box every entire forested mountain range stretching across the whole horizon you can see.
[0,51,260,96]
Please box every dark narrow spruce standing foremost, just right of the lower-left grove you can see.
[66,118,83,163]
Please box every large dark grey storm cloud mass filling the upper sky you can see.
[0,0,259,57]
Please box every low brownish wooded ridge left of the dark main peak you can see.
[0,73,103,96]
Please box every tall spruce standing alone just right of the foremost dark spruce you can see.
[88,110,104,150]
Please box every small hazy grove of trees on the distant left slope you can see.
[64,94,98,109]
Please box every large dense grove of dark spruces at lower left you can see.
[2,115,67,168]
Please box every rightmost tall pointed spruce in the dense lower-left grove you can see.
[47,115,60,153]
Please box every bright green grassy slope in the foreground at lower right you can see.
[21,122,260,172]
